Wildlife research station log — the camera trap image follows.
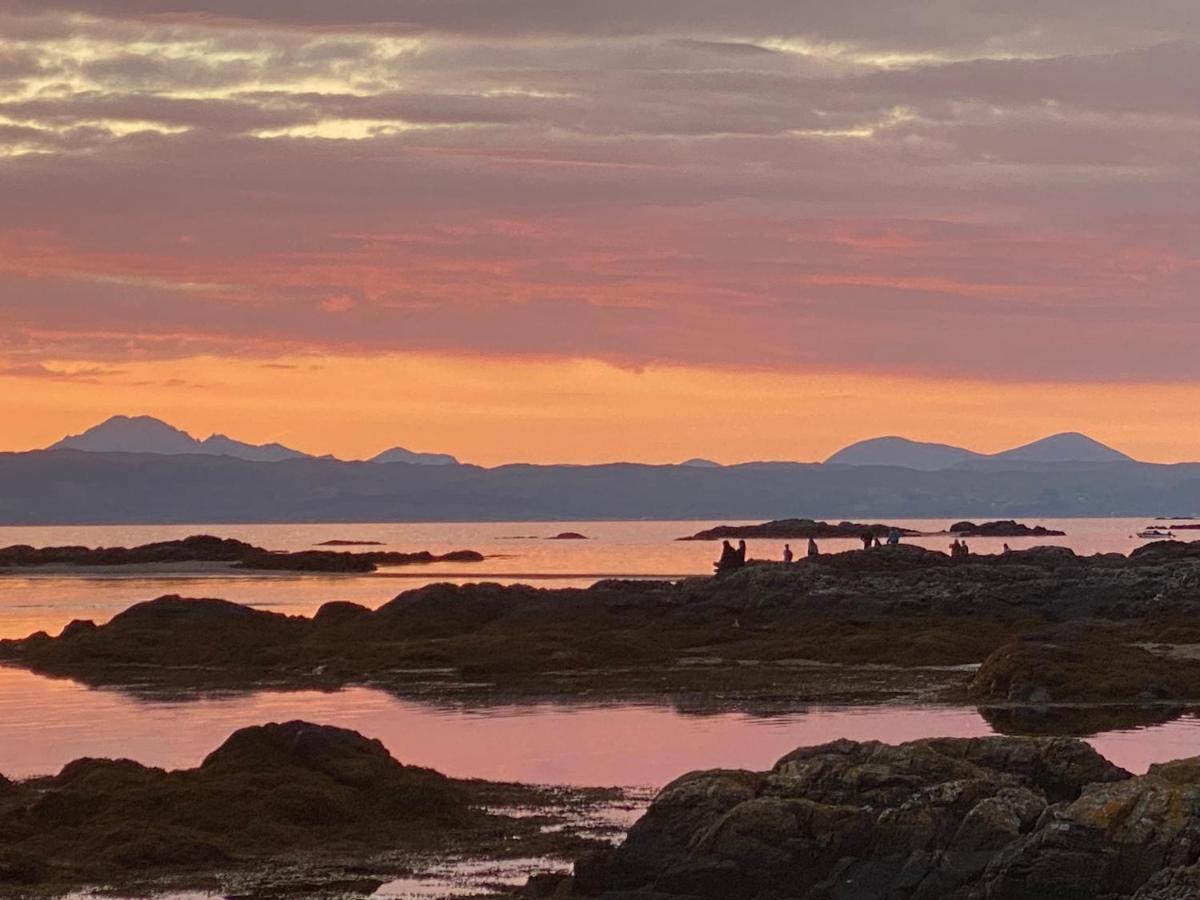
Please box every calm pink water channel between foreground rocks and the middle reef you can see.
[7,667,1200,787]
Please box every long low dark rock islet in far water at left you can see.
[0,534,484,572]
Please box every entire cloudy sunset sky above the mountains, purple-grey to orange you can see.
[0,0,1200,464]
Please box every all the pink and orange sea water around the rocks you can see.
[0,517,1200,898]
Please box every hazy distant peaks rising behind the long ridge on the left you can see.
[47,415,458,466]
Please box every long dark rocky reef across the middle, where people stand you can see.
[0,542,1200,704]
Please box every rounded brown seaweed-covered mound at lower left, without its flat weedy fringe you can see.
[0,721,477,893]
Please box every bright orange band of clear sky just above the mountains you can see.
[0,354,1200,466]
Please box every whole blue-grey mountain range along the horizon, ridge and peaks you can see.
[0,416,1180,534]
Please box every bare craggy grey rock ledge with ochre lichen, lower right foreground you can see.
[554,737,1200,900]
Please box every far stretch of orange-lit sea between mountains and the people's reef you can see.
[0,517,1171,637]
